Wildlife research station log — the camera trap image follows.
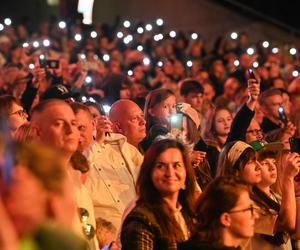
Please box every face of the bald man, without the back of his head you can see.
[119,103,146,145]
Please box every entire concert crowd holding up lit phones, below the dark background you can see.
[0,15,300,250]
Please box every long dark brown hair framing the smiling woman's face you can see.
[137,139,195,241]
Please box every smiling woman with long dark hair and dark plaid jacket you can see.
[121,139,195,250]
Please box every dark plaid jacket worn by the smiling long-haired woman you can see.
[121,206,177,250]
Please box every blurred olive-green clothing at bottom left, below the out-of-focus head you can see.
[34,224,88,250]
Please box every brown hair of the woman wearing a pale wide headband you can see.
[217,141,256,176]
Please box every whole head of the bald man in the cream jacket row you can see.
[109,99,146,148]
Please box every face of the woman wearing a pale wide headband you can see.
[240,160,262,184]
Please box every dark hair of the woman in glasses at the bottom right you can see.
[195,176,250,242]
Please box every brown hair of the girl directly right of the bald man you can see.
[144,88,175,131]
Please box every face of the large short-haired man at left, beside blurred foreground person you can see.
[37,103,79,153]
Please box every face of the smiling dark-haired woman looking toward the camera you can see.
[151,148,186,197]
